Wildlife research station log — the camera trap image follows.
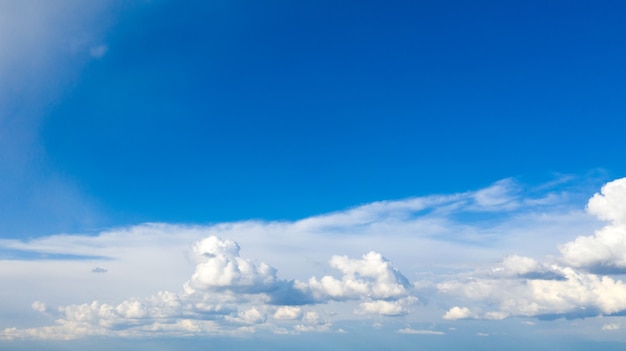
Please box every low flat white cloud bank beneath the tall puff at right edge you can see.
[438,266,626,319]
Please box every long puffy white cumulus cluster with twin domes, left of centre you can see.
[0,236,416,339]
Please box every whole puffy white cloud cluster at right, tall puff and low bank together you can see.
[437,178,626,320]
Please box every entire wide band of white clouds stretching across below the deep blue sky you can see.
[0,178,626,339]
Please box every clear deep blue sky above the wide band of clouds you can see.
[41,1,626,225]
